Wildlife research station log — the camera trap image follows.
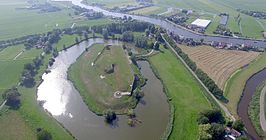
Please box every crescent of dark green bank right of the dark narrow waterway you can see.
[248,81,266,137]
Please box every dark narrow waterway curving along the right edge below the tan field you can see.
[237,69,266,140]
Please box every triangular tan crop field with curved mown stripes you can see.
[180,45,259,89]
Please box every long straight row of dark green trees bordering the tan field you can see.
[164,35,228,102]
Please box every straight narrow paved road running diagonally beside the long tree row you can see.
[162,35,236,121]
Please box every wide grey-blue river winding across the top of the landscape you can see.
[53,0,266,47]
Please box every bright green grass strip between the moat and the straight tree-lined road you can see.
[150,47,211,140]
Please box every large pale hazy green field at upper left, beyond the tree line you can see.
[0,0,110,40]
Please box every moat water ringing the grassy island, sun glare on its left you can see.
[37,39,169,140]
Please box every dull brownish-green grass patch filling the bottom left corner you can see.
[0,110,37,140]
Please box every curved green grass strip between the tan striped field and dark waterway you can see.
[224,53,266,116]
